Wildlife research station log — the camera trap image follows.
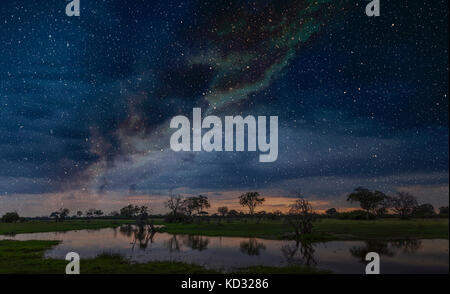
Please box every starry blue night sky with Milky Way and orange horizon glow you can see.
[0,0,449,215]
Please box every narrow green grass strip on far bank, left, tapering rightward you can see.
[0,219,134,235]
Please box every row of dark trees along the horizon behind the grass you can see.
[1,187,449,226]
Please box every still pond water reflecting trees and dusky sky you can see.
[0,229,448,274]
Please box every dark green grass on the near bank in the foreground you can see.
[0,240,328,274]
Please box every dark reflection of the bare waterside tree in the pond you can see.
[281,241,317,267]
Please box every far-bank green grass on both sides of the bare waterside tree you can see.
[157,219,449,241]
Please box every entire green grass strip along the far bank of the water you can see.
[0,219,449,241]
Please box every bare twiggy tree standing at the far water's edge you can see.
[286,197,314,239]
